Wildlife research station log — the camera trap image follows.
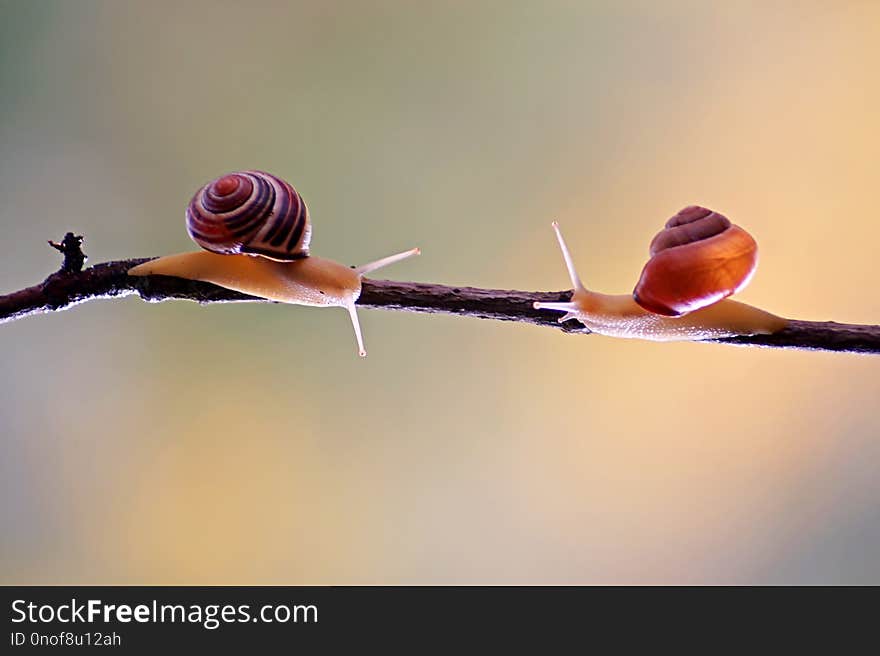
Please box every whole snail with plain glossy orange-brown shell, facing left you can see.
[534,205,786,342]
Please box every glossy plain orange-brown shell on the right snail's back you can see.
[633,205,758,316]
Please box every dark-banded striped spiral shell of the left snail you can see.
[186,171,312,261]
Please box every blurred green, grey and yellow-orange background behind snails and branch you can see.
[0,0,880,584]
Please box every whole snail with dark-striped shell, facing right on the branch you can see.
[128,171,420,356]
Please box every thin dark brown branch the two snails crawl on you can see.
[0,233,880,354]
